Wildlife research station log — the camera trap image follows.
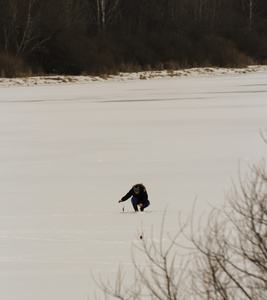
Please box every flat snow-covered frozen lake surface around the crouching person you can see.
[0,70,267,300]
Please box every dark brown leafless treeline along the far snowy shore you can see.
[0,0,267,77]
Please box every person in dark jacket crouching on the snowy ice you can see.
[119,183,150,211]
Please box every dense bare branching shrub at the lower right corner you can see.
[191,161,267,300]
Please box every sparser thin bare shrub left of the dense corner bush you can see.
[95,210,189,300]
